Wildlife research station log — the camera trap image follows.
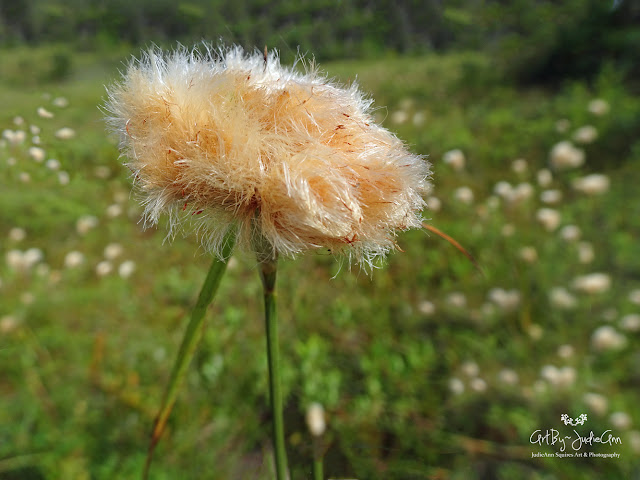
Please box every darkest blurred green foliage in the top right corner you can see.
[479,0,640,86]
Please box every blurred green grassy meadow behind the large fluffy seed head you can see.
[0,48,640,479]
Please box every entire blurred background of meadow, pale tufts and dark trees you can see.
[0,0,640,480]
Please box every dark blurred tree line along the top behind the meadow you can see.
[0,0,640,82]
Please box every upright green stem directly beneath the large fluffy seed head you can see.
[257,252,288,480]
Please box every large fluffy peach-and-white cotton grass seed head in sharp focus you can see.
[106,47,430,264]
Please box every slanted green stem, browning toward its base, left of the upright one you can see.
[142,227,237,479]
